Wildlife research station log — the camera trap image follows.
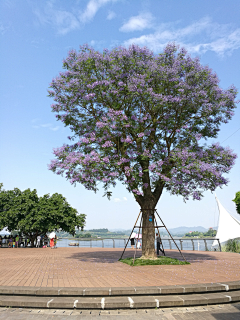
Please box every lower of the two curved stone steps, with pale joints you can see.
[0,291,240,310]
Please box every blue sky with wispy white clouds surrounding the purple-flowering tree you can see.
[0,0,240,229]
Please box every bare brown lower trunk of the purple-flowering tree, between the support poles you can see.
[141,201,156,259]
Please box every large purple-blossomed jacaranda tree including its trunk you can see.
[49,44,237,257]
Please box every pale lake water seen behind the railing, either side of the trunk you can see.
[57,238,219,251]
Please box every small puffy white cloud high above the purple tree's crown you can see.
[119,13,153,32]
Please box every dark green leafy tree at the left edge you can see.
[0,184,86,246]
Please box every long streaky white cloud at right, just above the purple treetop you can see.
[124,18,240,56]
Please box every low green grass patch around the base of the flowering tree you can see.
[119,256,190,266]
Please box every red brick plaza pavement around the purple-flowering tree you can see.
[0,248,240,287]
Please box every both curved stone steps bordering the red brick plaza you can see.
[0,281,240,310]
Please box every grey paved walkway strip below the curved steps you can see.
[0,303,240,320]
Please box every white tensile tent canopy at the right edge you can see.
[212,195,240,247]
